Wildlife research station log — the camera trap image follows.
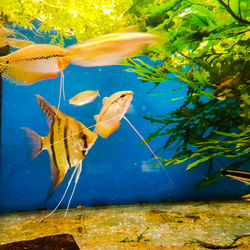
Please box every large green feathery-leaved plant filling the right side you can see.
[126,0,250,185]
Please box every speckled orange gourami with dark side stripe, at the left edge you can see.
[0,44,72,85]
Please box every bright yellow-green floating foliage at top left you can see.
[0,0,134,46]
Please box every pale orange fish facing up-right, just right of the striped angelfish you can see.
[95,91,133,138]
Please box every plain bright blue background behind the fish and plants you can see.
[0,27,247,212]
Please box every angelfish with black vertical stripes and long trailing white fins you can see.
[24,95,98,217]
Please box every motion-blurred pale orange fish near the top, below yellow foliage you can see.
[68,32,158,67]
